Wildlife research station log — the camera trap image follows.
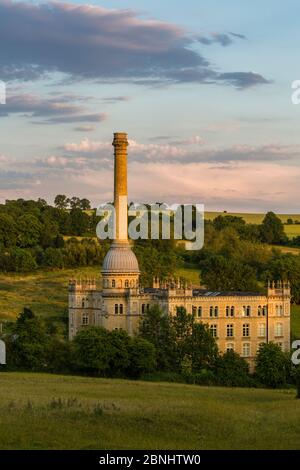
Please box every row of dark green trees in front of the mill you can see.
[2,306,300,388]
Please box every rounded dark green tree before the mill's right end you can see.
[255,342,287,388]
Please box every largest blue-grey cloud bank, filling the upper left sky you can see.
[0,0,268,88]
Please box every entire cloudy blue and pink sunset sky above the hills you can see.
[0,0,300,213]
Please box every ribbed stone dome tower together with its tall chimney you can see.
[101,132,140,291]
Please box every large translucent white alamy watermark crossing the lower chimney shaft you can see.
[96,201,204,250]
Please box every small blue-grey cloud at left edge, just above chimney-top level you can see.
[0,93,108,124]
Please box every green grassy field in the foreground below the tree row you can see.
[0,373,300,450]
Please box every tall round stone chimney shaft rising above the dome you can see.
[112,132,128,243]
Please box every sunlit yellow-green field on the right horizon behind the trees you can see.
[205,212,300,238]
